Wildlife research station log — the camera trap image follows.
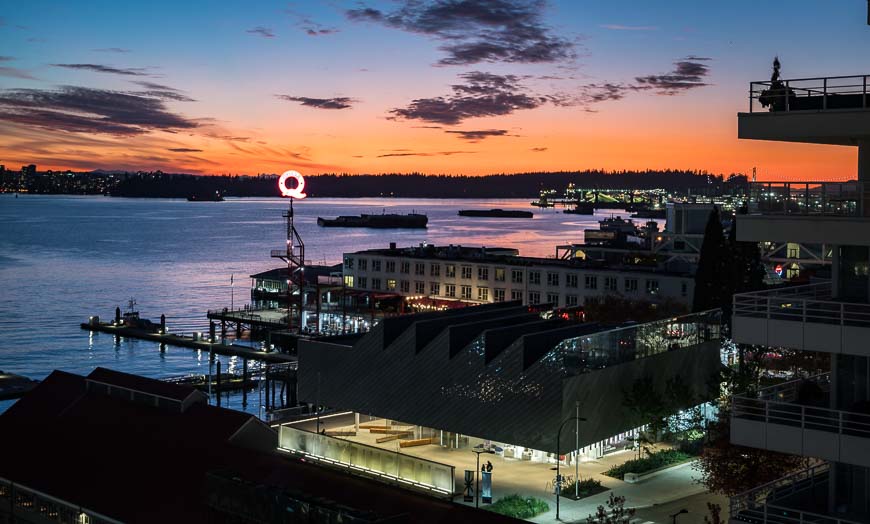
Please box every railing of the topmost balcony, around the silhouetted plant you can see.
[749,75,870,113]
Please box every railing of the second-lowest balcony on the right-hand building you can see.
[731,373,870,444]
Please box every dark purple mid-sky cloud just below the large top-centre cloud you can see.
[390,71,547,125]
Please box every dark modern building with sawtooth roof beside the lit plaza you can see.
[298,301,720,462]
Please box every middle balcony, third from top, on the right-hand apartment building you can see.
[732,283,870,356]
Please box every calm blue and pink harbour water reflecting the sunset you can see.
[0,195,624,412]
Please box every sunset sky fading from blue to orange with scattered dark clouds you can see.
[0,0,870,180]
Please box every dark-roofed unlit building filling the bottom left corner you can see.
[0,368,518,524]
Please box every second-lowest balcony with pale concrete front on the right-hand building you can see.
[731,373,870,467]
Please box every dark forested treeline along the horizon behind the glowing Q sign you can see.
[111,170,747,198]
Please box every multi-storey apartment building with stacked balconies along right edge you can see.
[731,71,870,524]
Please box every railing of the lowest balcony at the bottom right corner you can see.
[730,463,860,524]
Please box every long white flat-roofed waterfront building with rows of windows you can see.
[344,244,694,307]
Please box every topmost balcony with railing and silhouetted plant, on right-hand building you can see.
[737,75,870,145]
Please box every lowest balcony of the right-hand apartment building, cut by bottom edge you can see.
[729,464,861,524]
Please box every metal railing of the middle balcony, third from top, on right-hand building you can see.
[734,283,870,328]
